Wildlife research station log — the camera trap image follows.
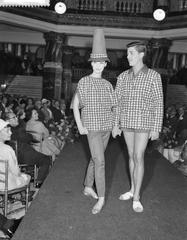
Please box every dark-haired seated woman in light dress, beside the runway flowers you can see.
[26,108,60,160]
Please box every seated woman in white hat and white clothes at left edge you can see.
[0,119,30,190]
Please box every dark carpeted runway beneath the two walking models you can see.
[13,137,187,240]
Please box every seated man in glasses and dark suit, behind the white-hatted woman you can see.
[5,113,51,187]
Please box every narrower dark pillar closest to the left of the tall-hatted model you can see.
[62,46,74,103]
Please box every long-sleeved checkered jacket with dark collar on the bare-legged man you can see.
[115,66,163,132]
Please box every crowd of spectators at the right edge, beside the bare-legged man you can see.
[154,104,187,176]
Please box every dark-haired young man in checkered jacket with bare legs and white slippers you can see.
[112,41,163,212]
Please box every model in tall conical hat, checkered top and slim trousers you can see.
[73,29,117,214]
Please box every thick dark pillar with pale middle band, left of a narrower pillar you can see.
[43,32,66,99]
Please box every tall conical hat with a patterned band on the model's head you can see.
[88,28,110,62]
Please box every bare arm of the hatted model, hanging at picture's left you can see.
[73,93,88,135]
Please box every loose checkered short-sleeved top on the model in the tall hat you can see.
[77,76,117,131]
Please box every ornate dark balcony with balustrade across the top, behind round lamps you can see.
[1,0,187,30]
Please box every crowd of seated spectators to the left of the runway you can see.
[0,94,79,237]
